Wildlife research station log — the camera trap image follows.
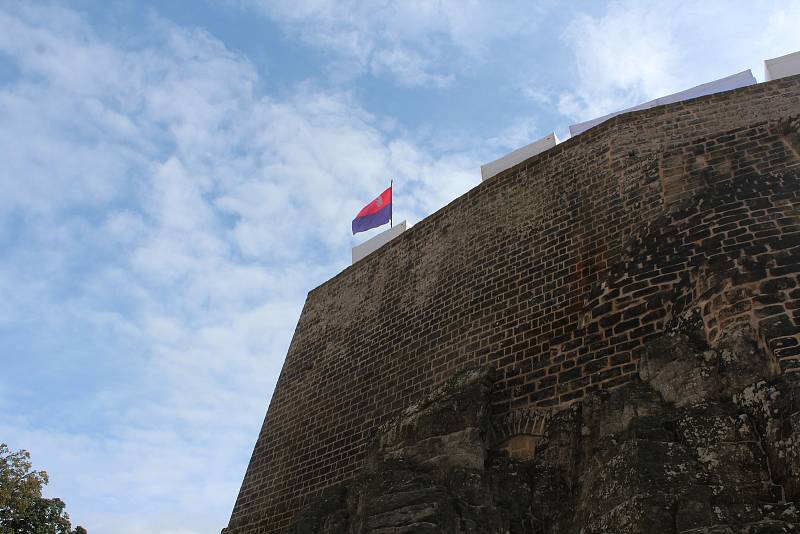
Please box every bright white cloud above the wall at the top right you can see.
[552,0,800,120]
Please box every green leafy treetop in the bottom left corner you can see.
[0,443,86,534]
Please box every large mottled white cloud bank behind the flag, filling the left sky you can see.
[0,3,478,534]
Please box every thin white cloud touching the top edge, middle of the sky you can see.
[231,0,547,87]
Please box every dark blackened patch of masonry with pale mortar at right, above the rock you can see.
[583,171,800,382]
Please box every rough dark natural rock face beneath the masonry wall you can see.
[289,324,800,534]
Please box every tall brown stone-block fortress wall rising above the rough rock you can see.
[222,77,800,534]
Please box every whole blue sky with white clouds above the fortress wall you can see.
[0,0,800,534]
